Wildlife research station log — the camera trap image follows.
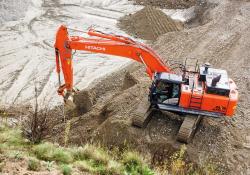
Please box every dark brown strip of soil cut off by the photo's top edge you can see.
[130,0,196,9]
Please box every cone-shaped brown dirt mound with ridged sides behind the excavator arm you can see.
[118,6,183,40]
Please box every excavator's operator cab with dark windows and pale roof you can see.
[150,72,183,105]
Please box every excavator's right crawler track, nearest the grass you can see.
[177,115,202,143]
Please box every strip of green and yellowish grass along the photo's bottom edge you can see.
[0,127,218,175]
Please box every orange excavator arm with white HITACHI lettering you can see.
[55,25,170,96]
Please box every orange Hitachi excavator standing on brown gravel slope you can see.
[55,26,238,143]
